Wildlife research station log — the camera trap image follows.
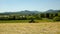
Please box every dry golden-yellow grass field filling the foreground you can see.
[0,22,60,34]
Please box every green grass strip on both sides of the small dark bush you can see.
[0,19,54,23]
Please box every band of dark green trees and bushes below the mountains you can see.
[0,12,60,21]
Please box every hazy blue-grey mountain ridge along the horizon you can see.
[0,9,60,15]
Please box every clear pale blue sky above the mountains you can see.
[0,0,60,12]
